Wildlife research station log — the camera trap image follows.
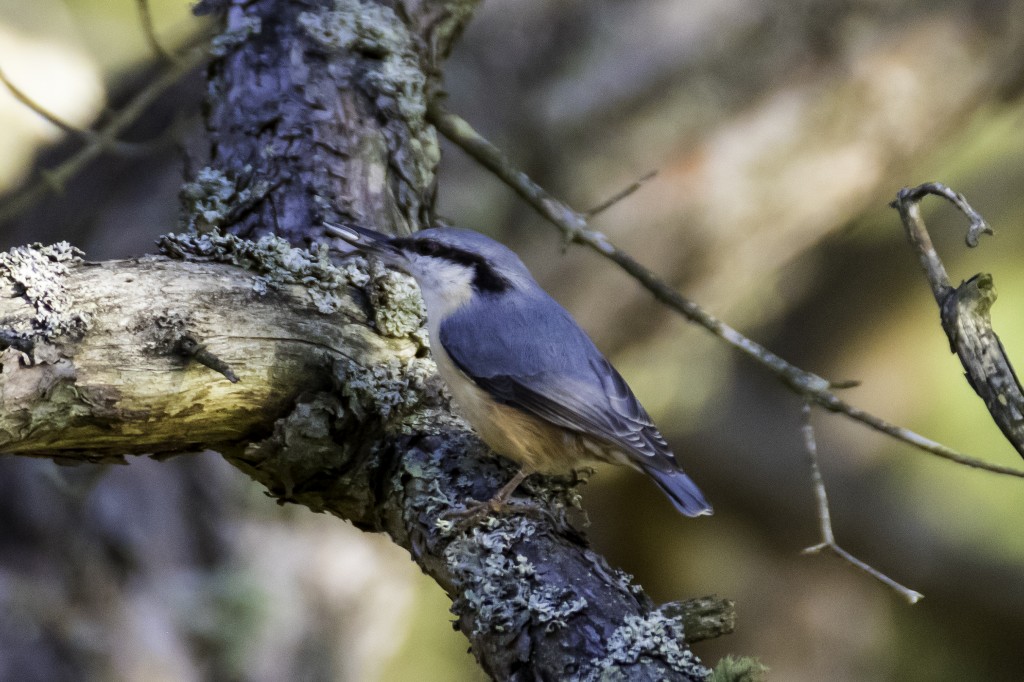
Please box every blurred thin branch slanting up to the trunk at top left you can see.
[0,45,207,223]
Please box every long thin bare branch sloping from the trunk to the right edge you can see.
[428,99,1024,478]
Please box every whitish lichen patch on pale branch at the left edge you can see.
[0,242,89,340]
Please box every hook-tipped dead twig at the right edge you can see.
[892,182,1024,456]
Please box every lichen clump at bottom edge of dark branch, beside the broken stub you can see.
[591,611,711,680]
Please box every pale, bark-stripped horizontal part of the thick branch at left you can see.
[0,235,418,460]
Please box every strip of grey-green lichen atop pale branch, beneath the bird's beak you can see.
[157,230,370,314]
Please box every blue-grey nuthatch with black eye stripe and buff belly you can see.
[328,225,712,516]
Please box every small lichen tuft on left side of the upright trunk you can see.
[180,165,270,232]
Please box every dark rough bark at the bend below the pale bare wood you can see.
[231,346,451,530]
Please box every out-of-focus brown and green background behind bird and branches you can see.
[0,0,1024,682]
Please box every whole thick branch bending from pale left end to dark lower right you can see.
[0,231,734,680]
